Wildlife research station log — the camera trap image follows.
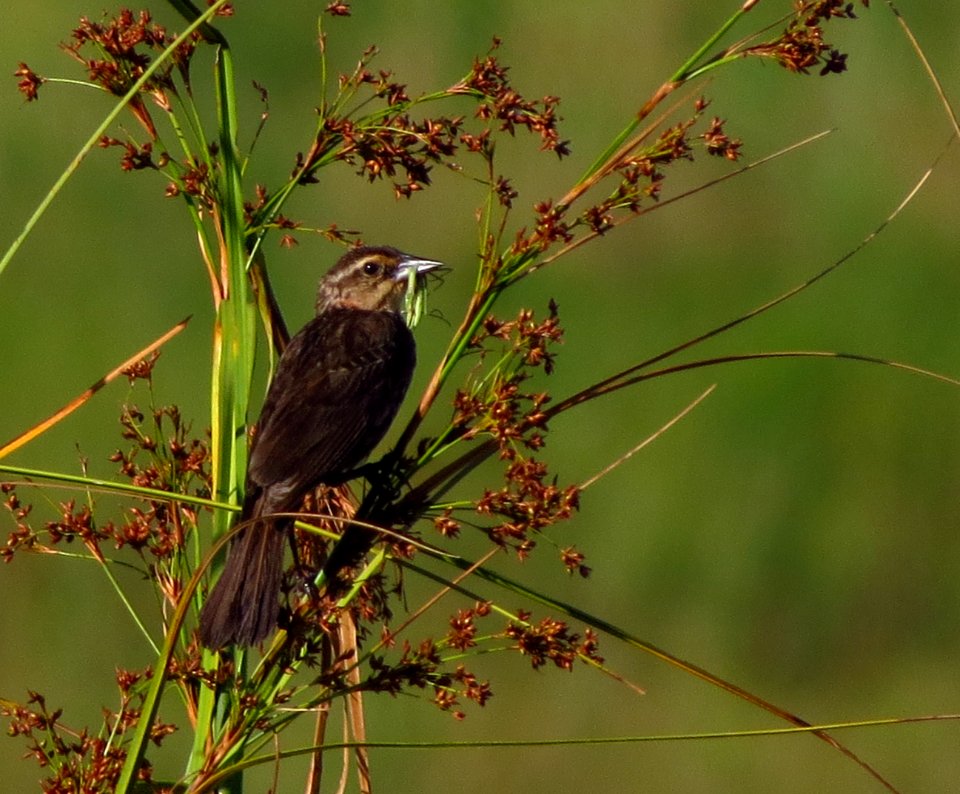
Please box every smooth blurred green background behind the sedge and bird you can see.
[0,0,960,794]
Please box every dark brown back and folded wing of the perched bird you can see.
[247,309,415,502]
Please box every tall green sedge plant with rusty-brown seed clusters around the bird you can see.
[0,0,956,792]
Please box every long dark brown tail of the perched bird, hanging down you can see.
[200,510,289,649]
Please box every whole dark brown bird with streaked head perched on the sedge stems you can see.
[200,247,440,648]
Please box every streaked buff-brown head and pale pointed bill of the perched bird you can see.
[317,246,442,314]
